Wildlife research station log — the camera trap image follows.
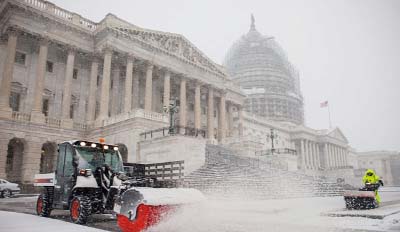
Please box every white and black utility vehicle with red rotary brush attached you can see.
[34,141,202,227]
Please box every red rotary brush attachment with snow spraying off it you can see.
[114,187,205,232]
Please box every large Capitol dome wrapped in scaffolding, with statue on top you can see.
[224,15,304,124]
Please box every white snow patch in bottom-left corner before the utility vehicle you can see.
[0,211,104,232]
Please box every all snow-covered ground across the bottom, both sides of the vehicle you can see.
[0,189,400,232]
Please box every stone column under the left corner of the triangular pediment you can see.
[98,48,113,123]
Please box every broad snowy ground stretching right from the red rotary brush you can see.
[150,192,400,232]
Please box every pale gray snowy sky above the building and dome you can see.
[51,0,400,151]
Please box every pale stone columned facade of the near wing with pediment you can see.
[0,0,244,186]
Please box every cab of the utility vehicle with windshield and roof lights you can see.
[53,141,123,209]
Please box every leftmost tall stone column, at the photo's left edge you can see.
[0,31,17,118]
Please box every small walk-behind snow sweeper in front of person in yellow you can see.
[344,182,381,209]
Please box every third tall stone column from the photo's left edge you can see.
[61,48,75,128]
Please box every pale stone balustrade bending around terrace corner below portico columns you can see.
[103,109,168,126]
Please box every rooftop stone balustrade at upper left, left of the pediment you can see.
[19,0,97,31]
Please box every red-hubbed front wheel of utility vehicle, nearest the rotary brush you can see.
[69,196,92,224]
